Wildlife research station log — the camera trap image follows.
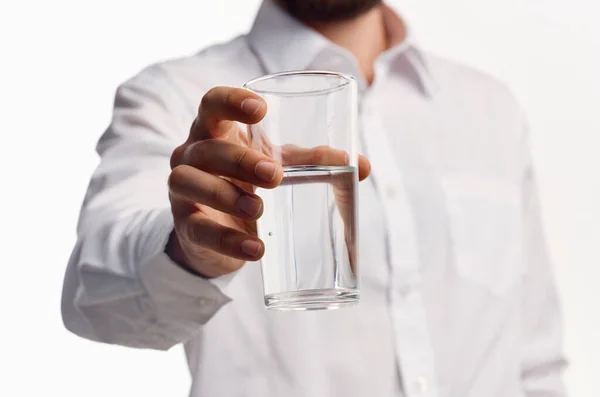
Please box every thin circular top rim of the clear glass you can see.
[242,70,356,97]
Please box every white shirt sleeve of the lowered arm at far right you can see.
[521,120,566,397]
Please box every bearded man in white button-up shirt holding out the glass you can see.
[63,0,565,397]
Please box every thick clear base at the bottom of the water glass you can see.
[265,288,360,311]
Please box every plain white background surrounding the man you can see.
[0,0,600,397]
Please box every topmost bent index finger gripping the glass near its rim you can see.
[190,87,267,141]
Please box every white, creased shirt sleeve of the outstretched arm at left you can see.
[62,65,229,350]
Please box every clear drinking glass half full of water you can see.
[244,71,360,310]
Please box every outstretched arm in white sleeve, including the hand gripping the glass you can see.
[62,67,369,349]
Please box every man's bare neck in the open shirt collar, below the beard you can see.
[307,7,388,84]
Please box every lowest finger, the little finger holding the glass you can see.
[179,212,264,261]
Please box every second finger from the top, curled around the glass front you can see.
[183,139,283,189]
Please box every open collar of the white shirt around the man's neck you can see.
[248,0,435,95]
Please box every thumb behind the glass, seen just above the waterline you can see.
[281,145,371,181]
